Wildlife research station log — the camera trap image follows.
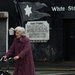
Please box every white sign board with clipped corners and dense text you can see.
[25,21,49,41]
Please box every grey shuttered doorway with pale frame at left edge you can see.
[0,12,8,57]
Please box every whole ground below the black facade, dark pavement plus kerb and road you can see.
[3,62,75,75]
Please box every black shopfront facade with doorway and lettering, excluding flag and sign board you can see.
[0,0,75,65]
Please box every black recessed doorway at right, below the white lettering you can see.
[63,19,75,61]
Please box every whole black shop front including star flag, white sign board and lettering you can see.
[0,0,75,67]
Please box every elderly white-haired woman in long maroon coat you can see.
[3,27,35,75]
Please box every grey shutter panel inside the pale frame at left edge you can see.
[0,18,6,56]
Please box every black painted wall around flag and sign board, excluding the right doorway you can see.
[0,0,75,61]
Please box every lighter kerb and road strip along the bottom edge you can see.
[4,68,75,75]
